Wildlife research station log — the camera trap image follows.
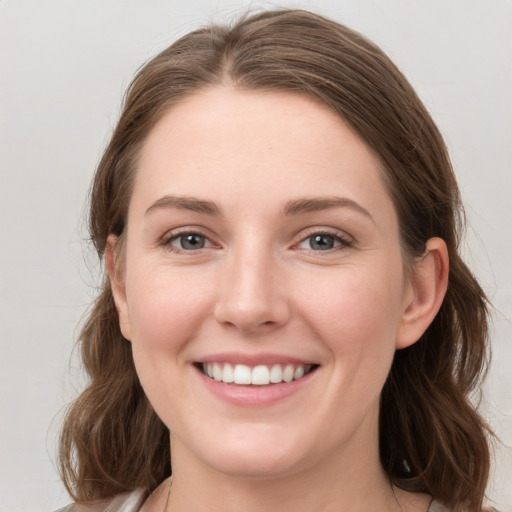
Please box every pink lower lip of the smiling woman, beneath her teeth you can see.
[196,368,318,407]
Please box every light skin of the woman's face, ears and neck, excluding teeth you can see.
[106,86,448,512]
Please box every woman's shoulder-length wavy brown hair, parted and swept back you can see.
[60,10,489,512]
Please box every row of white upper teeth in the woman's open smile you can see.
[202,363,312,386]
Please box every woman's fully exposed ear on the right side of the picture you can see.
[396,238,449,349]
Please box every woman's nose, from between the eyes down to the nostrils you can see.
[215,245,290,334]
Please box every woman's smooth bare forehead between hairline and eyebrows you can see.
[132,87,390,221]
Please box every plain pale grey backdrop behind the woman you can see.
[0,0,512,512]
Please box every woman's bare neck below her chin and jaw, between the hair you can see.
[168,418,401,512]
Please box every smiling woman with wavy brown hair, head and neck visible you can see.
[61,10,489,512]
